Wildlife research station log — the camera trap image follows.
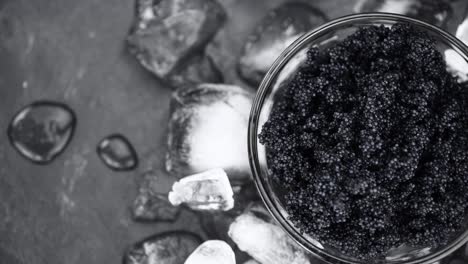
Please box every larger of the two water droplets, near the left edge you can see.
[8,101,76,164]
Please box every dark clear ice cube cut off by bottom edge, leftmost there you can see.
[124,231,202,264]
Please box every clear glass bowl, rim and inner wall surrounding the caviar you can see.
[248,13,468,264]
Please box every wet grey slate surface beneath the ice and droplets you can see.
[0,0,466,264]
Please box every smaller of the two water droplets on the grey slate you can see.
[97,134,138,171]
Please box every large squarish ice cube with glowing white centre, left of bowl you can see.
[166,84,253,184]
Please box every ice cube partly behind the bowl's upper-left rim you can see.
[238,3,327,85]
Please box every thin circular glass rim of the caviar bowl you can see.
[247,13,468,264]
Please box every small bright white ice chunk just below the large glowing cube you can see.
[169,169,234,211]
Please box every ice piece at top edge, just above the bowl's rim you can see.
[354,0,453,27]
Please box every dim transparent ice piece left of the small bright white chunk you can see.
[132,171,180,221]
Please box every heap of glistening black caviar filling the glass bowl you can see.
[259,24,468,259]
